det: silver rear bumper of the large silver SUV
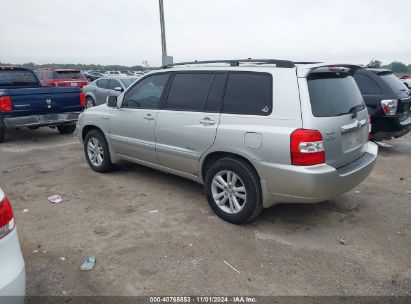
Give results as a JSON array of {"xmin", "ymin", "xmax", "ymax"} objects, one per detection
[{"xmin": 254, "ymin": 142, "xmax": 378, "ymax": 208}]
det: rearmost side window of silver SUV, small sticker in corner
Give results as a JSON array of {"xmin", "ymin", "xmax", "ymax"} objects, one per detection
[{"xmin": 223, "ymin": 73, "xmax": 272, "ymax": 115}]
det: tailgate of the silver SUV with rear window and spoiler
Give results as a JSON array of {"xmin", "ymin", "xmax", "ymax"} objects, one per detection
[{"xmin": 298, "ymin": 67, "xmax": 369, "ymax": 168}]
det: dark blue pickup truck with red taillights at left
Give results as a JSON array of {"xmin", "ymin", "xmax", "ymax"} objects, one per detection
[{"xmin": 0, "ymin": 67, "xmax": 86, "ymax": 142}]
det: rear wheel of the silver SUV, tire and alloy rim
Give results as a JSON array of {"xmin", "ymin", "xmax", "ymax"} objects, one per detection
[{"xmin": 205, "ymin": 158, "xmax": 262, "ymax": 224}]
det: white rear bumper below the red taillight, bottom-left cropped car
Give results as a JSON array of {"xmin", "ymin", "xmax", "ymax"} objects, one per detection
[{"xmin": 0, "ymin": 228, "xmax": 26, "ymax": 296}]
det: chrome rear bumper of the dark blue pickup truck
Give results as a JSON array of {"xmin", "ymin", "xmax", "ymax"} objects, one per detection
[{"xmin": 3, "ymin": 112, "xmax": 81, "ymax": 129}]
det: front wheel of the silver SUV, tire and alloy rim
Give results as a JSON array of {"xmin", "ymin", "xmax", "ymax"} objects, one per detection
[{"xmin": 84, "ymin": 130, "xmax": 113, "ymax": 173}]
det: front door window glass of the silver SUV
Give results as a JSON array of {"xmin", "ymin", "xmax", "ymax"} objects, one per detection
[{"xmin": 122, "ymin": 74, "xmax": 170, "ymax": 109}]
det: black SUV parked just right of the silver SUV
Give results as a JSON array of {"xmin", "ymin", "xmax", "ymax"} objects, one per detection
[{"xmin": 354, "ymin": 68, "xmax": 411, "ymax": 141}]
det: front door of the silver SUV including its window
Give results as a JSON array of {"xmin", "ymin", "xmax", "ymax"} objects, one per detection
[{"xmin": 109, "ymin": 74, "xmax": 170, "ymax": 164}]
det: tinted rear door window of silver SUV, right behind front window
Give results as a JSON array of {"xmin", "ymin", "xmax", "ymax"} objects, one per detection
[{"xmin": 166, "ymin": 73, "xmax": 214, "ymax": 111}]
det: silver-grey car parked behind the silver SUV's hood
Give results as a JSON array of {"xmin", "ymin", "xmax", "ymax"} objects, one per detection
[{"xmin": 83, "ymin": 76, "xmax": 137, "ymax": 108}]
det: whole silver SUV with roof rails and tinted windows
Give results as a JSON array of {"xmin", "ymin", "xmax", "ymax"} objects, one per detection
[{"xmin": 77, "ymin": 60, "xmax": 378, "ymax": 224}]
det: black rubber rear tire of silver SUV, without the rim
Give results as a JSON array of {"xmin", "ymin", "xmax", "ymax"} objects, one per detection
[{"xmin": 204, "ymin": 157, "xmax": 263, "ymax": 224}]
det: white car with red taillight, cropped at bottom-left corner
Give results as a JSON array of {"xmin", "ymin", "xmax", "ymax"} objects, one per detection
[{"xmin": 0, "ymin": 188, "xmax": 26, "ymax": 296}]
